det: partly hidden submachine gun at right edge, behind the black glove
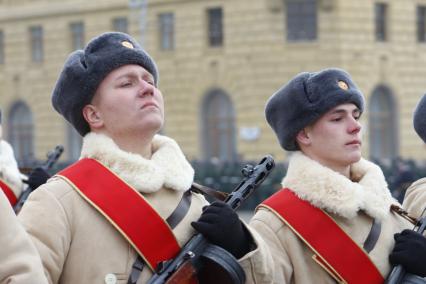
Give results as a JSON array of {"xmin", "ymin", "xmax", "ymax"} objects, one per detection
[{"xmin": 385, "ymin": 208, "xmax": 426, "ymax": 284}]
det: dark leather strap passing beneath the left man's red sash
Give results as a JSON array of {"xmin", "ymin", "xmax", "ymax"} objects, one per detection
[{"xmin": 127, "ymin": 190, "xmax": 192, "ymax": 284}]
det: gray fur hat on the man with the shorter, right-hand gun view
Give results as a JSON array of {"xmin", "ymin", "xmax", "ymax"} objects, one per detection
[{"xmin": 265, "ymin": 68, "xmax": 364, "ymax": 151}]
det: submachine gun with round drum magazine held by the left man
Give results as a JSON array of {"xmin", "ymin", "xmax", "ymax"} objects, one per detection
[{"xmin": 148, "ymin": 155, "xmax": 275, "ymax": 284}]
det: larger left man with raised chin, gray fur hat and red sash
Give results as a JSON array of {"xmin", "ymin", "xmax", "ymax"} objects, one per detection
[{"xmin": 19, "ymin": 32, "xmax": 266, "ymax": 283}]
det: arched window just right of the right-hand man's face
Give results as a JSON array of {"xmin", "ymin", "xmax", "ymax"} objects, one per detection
[{"xmin": 369, "ymin": 86, "xmax": 398, "ymax": 159}]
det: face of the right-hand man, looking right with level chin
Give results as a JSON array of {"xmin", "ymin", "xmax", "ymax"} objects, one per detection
[{"xmin": 299, "ymin": 103, "xmax": 362, "ymax": 169}]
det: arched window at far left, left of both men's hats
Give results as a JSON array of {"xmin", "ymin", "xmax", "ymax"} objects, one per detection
[{"xmin": 8, "ymin": 102, "xmax": 34, "ymax": 166}]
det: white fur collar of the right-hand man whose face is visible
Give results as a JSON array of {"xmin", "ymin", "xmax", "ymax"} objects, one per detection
[{"xmin": 282, "ymin": 152, "xmax": 397, "ymax": 220}]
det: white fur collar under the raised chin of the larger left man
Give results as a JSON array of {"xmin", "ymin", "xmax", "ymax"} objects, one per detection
[{"xmin": 81, "ymin": 133, "xmax": 194, "ymax": 193}]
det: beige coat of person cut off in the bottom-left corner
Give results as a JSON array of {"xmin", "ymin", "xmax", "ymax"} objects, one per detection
[{"xmin": 0, "ymin": 190, "xmax": 47, "ymax": 284}]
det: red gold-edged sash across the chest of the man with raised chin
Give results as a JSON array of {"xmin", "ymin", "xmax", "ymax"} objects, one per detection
[{"xmin": 57, "ymin": 158, "xmax": 180, "ymax": 270}]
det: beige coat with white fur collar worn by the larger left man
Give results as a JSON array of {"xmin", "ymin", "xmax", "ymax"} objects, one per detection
[{"xmin": 19, "ymin": 133, "xmax": 262, "ymax": 284}]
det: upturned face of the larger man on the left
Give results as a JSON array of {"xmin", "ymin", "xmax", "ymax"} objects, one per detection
[{"xmin": 88, "ymin": 65, "xmax": 164, "ymax": 140}]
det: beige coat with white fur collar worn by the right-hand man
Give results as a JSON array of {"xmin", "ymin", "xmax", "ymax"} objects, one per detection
[{"xmin": 250, "ymin": 152, "xmax": 412, "ymax": 284}]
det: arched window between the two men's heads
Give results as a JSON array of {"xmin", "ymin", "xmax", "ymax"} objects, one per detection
[{"xmin": 201, "ymin": 89, "xmax": 237, "ymax": 161}]
